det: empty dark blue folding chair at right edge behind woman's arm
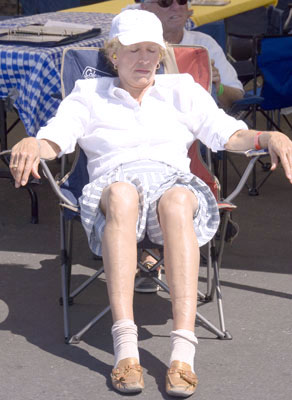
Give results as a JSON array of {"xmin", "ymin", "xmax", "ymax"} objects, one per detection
[{"xmin": 229, "ymin": 35, "xmax": 292, "ymax": 195}]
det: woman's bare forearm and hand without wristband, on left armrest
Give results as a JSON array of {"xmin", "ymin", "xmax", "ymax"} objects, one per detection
[{"xmin": 9, "ymin": 138, "xmax": 60, "ymax": 188}]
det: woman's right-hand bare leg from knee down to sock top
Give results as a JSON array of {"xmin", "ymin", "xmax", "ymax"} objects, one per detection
[{"xmin": 158, "ymin": 187, "xmax": 200, "ymax": 332}]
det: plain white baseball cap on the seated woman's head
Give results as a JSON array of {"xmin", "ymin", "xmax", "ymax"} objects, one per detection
[{"xmin": 109, "ymin": 10, "xmax": 166, "ymax": 49}]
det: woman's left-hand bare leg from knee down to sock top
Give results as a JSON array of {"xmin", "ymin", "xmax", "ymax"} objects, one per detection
[{"xmin": 101, "ymin": 182, "xmax": 139, "ymax": 322}]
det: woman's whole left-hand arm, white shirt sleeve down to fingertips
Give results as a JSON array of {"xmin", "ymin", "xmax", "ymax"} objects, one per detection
[{"xmin": 10, "ymin": 79, "xmax": 96, "ymax": 188}]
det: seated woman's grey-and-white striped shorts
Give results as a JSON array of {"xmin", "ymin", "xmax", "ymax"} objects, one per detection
[{"xmin": 79, "ymin": 160, "xmax": 219, "ymax": 256}]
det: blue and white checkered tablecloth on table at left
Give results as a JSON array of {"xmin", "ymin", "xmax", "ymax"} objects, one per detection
[{"xmin": 0, "ymin": 12, "xmax": 113, "ymax": 136}]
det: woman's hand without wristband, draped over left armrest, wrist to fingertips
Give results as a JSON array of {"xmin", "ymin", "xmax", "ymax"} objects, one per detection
[{"xmin": 9, "ymin": 138, "xmax": 40, "ymax": 188}]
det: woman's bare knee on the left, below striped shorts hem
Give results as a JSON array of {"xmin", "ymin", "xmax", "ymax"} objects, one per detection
[{"xmin": 101, "ymin": 182, "xmax": 139, "ymax": 218}]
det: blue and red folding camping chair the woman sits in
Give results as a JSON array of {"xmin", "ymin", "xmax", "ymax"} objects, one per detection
[{"xmin": 32, "ymin": 46, "xmax": 266, "ymax": 343}]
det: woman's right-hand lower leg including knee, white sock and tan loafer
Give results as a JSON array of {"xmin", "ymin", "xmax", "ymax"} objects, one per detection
[{"xmin": 158, "ymin": 187, "xmax": 199, "ymax": 378}]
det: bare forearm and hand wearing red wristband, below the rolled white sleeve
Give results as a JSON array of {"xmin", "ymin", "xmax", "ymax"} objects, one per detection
[{"xmin": 225, "ymin": 130, "xmax": 292, "ymax": 183}]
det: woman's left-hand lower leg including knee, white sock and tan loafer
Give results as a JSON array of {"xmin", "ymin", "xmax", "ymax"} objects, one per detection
[{"xmin": 101, "ymin": 182, "xmax": 144, "ymax": 393}]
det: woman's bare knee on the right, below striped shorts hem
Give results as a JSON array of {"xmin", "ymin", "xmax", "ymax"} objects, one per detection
[{"xmin": 158, "ymin": 187, "xmax": 198, "ymax": 220}]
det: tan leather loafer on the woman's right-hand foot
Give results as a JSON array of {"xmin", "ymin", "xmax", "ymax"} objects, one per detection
[{"xmin": 166, "ymin": 361, "xmax": 198, "ymax": 397}]
